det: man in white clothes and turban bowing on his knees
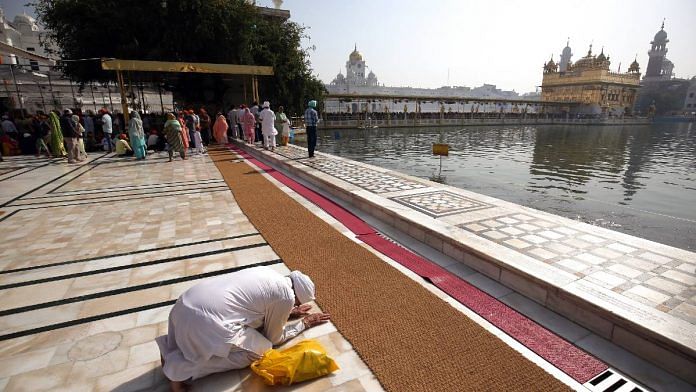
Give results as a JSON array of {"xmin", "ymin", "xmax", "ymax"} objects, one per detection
[{"xmin": 156, "ymin": 267, "xmax": 329, "ymax": 392}]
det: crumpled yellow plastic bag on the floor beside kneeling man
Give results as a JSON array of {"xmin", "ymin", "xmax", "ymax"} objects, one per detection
[{"xmin": 251, "ymin": 340, "xmax": 338, "ymax": 385}]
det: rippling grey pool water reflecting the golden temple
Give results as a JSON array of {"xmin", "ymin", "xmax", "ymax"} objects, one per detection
[{"xmin": 304, "ymin": 124, "xmax": 696, "ymax": 249}]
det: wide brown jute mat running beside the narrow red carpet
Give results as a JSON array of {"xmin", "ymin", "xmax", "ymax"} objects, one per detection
[{"xmin": 209, "ymin": 148, "xmax": 570, "ymax": 391}]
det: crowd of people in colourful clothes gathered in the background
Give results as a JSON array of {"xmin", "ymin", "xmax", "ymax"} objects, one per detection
[{"xmin": 0, "ymin": 101, "xmax": 318, "ymax": 164}]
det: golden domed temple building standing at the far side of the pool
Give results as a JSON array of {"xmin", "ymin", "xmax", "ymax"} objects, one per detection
[{"xmin": 541, "ymin": 45, "xmax": 640, "ymax": 116}]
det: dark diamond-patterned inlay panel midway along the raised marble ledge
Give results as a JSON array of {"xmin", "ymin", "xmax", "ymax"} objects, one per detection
[{"xmin": 390, "ymin": 191, "xmax": 493, "ymax": 218}]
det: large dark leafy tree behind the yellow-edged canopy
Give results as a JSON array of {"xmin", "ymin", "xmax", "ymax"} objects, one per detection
[{"xmin": 32, "ymin": 0, "xmax": 324, "ymax": 112}]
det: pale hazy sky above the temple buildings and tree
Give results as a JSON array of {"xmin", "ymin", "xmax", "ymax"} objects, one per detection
[{"xmin": 0, "ymin": 0, "xmax": 696, "ymax": 93}]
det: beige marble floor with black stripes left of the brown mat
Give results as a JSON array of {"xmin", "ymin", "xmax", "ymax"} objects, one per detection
[{"xmin": 0, "ymin": 154, "xmax": 381, "ymax": 391}]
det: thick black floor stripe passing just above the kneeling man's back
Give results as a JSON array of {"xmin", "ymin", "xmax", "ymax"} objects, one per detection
[{"xmin": 0, "ymin": 259, "xmax": 277, "ymax": 317}]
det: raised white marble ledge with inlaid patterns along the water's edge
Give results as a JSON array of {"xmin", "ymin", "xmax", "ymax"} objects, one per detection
[{"xmin": 245, "ymin": 145, "xmax": 696, "ymax": 383}]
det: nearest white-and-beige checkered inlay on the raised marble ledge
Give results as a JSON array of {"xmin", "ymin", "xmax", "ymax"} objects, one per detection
[{"xmin": 458, "ymin": 213, "xmax": 696, "ymax": 323}]
